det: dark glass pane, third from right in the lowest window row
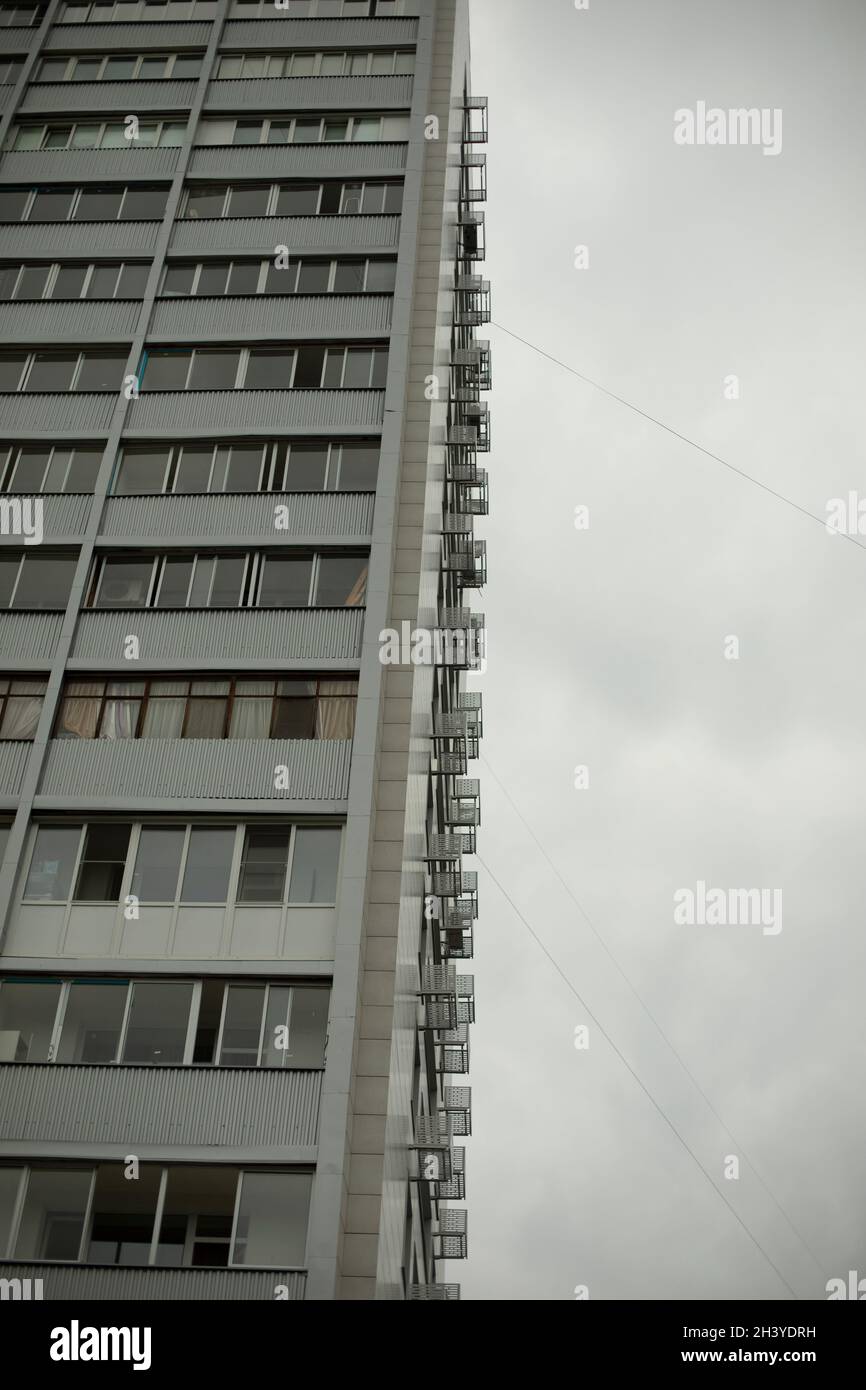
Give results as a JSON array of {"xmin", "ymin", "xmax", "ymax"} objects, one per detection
[{"xmin": 86, "ymin": 1162, "xmax": 163, "ymax": 1266}]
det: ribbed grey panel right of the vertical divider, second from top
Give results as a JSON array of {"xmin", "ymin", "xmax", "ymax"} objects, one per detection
[{"xmin": 204, "ymin": 73, "xmax": 413, "ymax": 111}]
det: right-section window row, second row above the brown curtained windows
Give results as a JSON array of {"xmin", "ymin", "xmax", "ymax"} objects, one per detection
[{"xmin": 111, "ymin": 439, "xmax": 379, "ymax": 496}]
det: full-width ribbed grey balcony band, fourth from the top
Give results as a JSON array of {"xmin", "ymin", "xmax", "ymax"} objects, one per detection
[{"xmin": 0, "ymin": 215, "xmax": 400, "ymax": 260}]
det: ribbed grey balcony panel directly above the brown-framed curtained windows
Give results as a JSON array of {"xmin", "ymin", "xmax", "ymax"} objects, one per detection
[{"xmin": 69, "ymin": 609, "xmax": 364, "ymax": 670}]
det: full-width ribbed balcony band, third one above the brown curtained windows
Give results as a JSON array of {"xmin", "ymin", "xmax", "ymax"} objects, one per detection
[{"xmin": 0, "ymin": 391, "xmax": 385, "ymax": 442}]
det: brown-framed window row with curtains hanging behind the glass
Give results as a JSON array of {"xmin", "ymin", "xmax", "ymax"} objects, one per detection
[{"xmin": 54, "ymin": 677, "xmax": 357, "ymax": 745}]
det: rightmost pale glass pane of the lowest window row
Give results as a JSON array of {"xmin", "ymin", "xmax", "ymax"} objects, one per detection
[{"xmin": 232, "ymin": 1173, "xmax": 313, "ymax": 1268}]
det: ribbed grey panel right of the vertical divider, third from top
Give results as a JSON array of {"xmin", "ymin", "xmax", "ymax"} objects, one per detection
[{"xmin": 187, "ymin": 140, "xmax": 409, "ymax": 179}]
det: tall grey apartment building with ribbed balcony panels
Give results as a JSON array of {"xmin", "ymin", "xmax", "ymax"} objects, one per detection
[{"xmin": 0, "ymin": 0, "xmax": 491, "ymax": 1300}]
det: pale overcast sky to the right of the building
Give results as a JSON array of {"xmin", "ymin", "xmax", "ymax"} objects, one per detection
[{"xmin": 461, "ymin": 0, "xmax": 866, "ymax": 1300}]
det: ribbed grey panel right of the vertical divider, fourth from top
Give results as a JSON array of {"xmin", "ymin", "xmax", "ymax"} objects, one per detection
[{"xmin": 169, "ymin": 215, "xmax": 400, "ymax": 256}]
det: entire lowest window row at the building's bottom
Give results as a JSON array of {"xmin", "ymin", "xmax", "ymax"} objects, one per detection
[{"xmin": 0, "ymin": 1161, "xmax": 313, "ymax": 1269}]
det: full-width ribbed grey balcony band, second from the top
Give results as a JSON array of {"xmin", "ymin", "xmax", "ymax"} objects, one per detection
[{"xmin": 18, "ymin": 72, "xmax": 413, "ymax": 115}]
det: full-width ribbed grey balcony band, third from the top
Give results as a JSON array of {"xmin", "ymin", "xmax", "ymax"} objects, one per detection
[{"xmin": 0, "ymin": 140, "xmax": 409, "ymax": 183}]
